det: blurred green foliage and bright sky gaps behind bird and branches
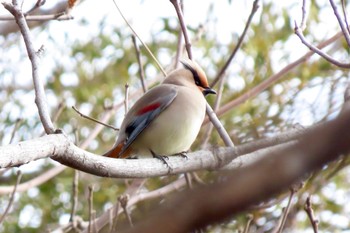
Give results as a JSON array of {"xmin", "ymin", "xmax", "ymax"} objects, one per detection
[{"xmin": 0, "ymin": 0, "xmax": 350, "ymax": 232}]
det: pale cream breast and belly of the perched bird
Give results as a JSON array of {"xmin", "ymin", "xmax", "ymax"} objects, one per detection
[{"xmin": 133, "ymin": 87, "xmax": 206, "ymax": 155}]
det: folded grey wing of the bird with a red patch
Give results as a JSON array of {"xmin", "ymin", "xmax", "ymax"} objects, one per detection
[{"xmin": 119, "ymin": 85, "xmax": 178, "ymax": 155}]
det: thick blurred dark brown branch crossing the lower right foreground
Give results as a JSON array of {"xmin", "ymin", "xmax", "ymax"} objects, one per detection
[{"xmin": 122, "ymin": 107, "xmax": 350, "ymax": 233}]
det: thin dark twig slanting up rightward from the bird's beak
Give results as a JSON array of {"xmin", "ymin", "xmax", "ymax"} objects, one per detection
[{"xmin": 210, "ymin": 0, "xmax": 259, "ymax": 87}]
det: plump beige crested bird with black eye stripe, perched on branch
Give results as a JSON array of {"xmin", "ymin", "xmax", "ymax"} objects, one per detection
[{"xmin": 104, "ymin": 60, "xmax": 216, "ymax": 163}]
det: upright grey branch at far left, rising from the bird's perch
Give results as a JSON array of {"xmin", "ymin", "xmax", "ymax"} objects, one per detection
[{"xmin": 2, "ymin": 0, "xmax": 55, "ymax": 134}]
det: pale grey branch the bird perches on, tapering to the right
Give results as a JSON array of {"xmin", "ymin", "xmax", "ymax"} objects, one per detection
[{"xmin": 0, "ymin": 118, "xmax": 321, "ymax": 178}]
